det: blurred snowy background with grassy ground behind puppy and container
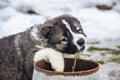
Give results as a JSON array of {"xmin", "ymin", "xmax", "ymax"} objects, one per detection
[{"xmin": 0, "ymin": 0, "xmax": 120, "ymax": 80}]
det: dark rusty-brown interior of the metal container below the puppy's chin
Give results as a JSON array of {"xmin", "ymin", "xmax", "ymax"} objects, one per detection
[{"xmin": 35, "ymin": 58, "xmax": 99, "ymax": 72}]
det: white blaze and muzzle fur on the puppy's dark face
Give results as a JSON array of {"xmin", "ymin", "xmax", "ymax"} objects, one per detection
[{"xmin": 62, "ymin": 20, "xmax": 86, "ymax": 50}]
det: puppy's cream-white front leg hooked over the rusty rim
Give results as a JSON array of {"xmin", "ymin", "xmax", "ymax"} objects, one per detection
[{"xmin": 33, "ymin": 48, "xmax": 64, "ymax": 72}]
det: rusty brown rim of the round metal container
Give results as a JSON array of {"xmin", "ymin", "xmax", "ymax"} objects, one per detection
[{"xmin": 34, "ymin": 59, "xmax": 99, "ymax": 76}]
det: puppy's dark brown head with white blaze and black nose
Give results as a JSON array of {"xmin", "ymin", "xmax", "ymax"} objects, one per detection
[{"xmin": 41, "ymin": 15, "xmax": 86, "ymax": 54}]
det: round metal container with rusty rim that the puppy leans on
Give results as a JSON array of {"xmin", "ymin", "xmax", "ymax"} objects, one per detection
[{"xmin": 32, "ymin": 58, "xmax": 100, "ymax": 80}]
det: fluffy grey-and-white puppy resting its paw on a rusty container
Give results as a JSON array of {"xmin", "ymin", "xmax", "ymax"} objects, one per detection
[{"xmin": 0, "ymin": 14, "xmax": 86, "ymax": 80}]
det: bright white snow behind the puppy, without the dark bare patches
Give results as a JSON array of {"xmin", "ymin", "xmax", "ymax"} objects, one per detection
[{"xmin": 0, "ymin": 0, "xmax": 120, "ymax": 40}]
